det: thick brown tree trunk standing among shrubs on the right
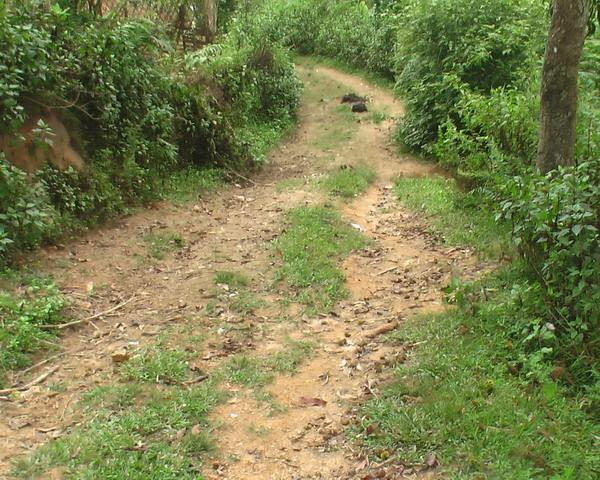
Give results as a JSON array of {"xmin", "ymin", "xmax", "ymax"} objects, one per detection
[{"xmin": 537, "ymin": 0, "xmax": 589, "ymax": 174}]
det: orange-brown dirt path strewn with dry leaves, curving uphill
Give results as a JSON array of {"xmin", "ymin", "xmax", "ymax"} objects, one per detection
[{"xmin": 0, "ymin": 61, "xmax": 478, "ymax": 480}]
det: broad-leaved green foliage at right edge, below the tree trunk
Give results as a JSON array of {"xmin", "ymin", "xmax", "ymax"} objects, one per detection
[{"xmin": 502, "ymin": 161, "xmax": 600, "ymax": 381}]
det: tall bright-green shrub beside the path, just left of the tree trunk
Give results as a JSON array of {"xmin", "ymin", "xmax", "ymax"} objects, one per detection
[{"xmin": 396, "ymin": 0, "xmax": 545, "ymax": 149}]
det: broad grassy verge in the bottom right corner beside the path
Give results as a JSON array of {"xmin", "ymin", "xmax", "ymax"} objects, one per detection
[{"xmin": 358, "ymin": 270, "xmax": 600, "ymax": 480}]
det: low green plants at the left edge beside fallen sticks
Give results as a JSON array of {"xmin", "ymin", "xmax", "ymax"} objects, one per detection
[{"xmin": 0, "ymin": 270, "xmax": 66, "ymax": 385}]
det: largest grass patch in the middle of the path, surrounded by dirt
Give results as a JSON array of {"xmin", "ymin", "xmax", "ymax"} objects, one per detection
[{"xmin": 274, "ymin": 207, "xmax": 367, "ymax": 313}]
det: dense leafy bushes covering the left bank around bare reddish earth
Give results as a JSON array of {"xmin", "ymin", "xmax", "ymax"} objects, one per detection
[{"xmin": 0, "ymin": 0, "xmax": 300, "ymax": 259}]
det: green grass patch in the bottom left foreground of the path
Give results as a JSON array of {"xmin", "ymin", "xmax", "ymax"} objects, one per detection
[{"xmin": 14, "ymin": 380, "xmax": 224, "ymax": 480}]
